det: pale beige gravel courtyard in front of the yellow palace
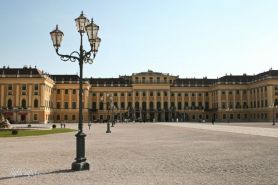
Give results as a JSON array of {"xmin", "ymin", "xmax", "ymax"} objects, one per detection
[{"xmin": 0, "ymin": 123, "xmax": 278, "ymax": 185}]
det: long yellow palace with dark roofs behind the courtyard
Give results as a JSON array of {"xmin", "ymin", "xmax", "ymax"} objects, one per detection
[{"xmin": 0, "ymin": 67, "xmax": 278, "ymax": 123}]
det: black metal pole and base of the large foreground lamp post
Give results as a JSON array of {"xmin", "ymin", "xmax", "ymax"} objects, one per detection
[{"xmin": 71, "ymin": 33, "xmax": 90, "ymax": 171}]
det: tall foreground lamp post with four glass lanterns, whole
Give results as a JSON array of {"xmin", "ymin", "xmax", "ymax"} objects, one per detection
[{"xmin": 50, "ymin": 12, "xmax": 101, "ymax": 171}]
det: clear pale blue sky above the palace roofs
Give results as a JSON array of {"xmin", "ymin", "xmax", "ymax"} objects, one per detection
[{"xmin": 0, "ymin": 0, "xmax": 278, "ymax": 78}]
